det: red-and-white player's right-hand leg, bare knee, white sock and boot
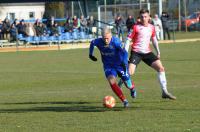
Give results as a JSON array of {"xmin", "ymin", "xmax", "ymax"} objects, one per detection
[{"xmin": 151, "ymin": 60, "xmax": 176, "ymax": 99}]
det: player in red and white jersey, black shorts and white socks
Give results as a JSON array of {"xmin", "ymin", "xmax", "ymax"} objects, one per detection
[{"xmin": 125, "ymin": 9, "xmax": 176, "ymax": 100}]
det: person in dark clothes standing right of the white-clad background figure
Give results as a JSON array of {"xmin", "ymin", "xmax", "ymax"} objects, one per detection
[{"xmin": 161, "ymin": 12, "xmax": 170, "ymax": 40}]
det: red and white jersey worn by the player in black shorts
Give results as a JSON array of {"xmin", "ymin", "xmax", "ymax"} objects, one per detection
[{"xmin": 128, "ymin": 24, "xmax": 155, "ymax": 54}]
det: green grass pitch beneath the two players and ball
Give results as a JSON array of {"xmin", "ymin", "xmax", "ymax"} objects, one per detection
[{"xmin": 0, "ymin": 42, "xmax": 200, "ymax": 132}]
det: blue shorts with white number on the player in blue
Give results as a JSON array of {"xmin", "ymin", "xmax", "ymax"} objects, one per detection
[{"xmin": 104, "ymin": 66, "xmax": 130, "ymax": 81}]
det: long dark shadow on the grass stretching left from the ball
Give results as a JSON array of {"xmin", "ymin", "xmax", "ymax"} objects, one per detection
[{"xmin": 0, "ymin": 102, "xmax": 124, "ymax": 113}]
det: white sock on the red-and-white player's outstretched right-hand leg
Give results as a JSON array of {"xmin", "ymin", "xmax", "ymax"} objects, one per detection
[{"xmin": 158, "ymin": 72, "xmax": 168, "ymax": 93}]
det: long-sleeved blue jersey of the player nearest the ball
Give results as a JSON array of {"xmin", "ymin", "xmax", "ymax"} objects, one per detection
[{"xmin": 89, "ymin": 37, "xmax": 128, "ymax": 68}]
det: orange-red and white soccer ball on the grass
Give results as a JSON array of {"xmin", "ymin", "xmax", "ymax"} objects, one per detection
[{"xmin": 103, "ymin": 95, "xmax": 116, "ymax": 108}]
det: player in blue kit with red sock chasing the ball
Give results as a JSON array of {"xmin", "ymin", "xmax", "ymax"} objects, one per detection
[{"xmin": 89, "ymin": 28, "xmax": 136, "ymax": 107}]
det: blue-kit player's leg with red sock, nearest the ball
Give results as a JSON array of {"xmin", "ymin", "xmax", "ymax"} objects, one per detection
[{"xmin": 105, "ymin": 69, "xmax": 128, "ymax": 107}]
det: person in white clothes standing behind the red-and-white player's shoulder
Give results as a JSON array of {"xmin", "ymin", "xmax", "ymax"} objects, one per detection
[{"xmin": 153, "ymin": 14, "xmax": 162, "ymax": 40}]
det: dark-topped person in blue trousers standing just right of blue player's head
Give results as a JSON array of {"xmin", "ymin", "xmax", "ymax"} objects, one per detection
[{"xmin": 115, "ymin": 15, "xmax": 125, "ymax": 41}]
